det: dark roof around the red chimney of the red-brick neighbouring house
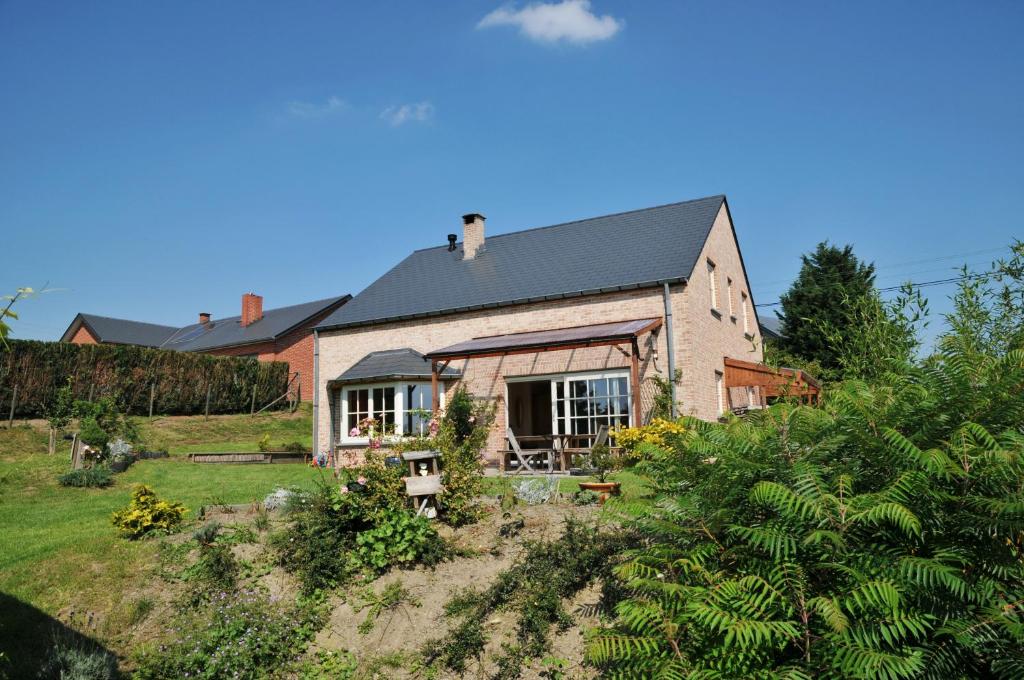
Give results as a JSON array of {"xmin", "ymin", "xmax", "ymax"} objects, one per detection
[{"xmin": 161, "ymin": 295, "xmax": 351, "ymax": 351}]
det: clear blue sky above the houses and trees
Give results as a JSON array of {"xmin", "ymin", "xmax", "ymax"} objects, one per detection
[{"xmin": 0, "ymin": 0, "xmax": 1024, "ymax": 346}]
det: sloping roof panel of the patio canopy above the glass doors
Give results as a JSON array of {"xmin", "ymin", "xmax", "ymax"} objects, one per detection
[{"xmin": 427, "ymin": 318, "xmax": 662, "ymax": 359}]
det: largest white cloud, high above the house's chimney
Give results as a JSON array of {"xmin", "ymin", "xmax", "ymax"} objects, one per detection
[{"xmin": 476, "ymin": 0, "xmax": 626, "ymax": 45}]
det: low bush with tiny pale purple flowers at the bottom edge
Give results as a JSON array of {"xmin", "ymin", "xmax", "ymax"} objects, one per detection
[{"xmin": 134, "ymin": 591, "xmax": 324, "ymax": 680}]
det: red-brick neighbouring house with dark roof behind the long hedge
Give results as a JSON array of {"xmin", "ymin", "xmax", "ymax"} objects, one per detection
[{"xmin": 60, "ymin": 293, "xmax": 352, "ymax": 400}]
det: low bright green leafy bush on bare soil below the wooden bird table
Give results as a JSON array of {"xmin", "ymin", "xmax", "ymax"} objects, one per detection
[{"xmin": 350, "ymin": 510, "xmax": 443, "ymax": 571}]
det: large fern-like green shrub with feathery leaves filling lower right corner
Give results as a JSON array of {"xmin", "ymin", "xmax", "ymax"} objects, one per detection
[{"xmin": 588, "ymin": 345, "xmax": 1024, "ymax": 680}]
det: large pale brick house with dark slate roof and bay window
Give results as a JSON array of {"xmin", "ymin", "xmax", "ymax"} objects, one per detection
[{"xmin": 313, "ymin": 196, "xmax": 762, "ymax": 462}]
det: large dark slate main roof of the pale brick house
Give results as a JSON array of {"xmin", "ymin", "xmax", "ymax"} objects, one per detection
[{"xmin": 319, "ymin": 196, "xmax": 725, "ymax": 330}]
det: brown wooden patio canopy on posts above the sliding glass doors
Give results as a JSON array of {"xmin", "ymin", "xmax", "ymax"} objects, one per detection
[{"xmin": 424, "ymin": 318, "xmax": 662, "ymax": 423}]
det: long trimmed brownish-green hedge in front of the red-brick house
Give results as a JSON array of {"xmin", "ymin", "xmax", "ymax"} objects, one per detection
[{"xmin": 0, "ymin": 340, "xmax": 289, "ymax": 418}]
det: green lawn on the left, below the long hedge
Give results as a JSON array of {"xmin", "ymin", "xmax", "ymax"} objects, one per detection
[{"xmin": 0, "ymin": 411, "xmax": 319, "ymax": 673}]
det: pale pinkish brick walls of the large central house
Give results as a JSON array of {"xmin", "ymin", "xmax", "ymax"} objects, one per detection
[{"xmin": 315, "ymin": 200, "xmax": 761, "ymax": 460}]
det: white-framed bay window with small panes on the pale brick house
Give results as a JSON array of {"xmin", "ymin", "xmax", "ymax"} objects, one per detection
[{"xmin": 332, "ymin": 383, "xmax": 443, "ymax": 443}]
